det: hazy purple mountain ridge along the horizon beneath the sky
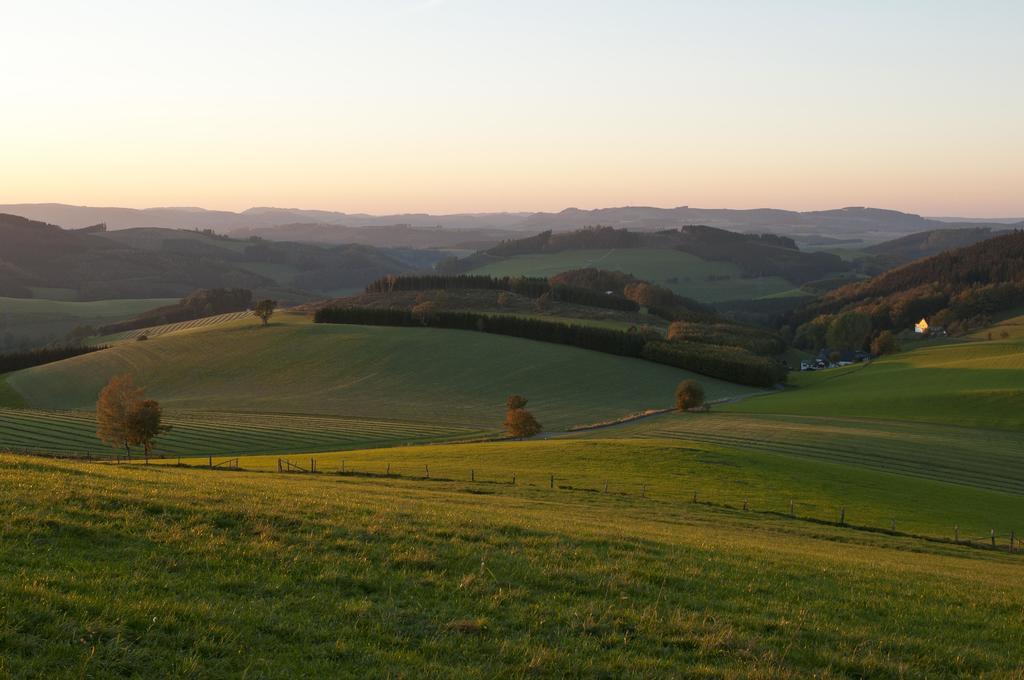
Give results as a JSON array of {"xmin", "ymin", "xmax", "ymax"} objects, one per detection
[{"xmin": 0, "ymin": 203, "xmax": 1024, "ymax": 246}]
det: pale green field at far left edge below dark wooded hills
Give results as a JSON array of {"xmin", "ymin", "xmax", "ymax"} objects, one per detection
[{"xmin": 0, "ymin": 298, "xmax": 177, "ymax": 347}]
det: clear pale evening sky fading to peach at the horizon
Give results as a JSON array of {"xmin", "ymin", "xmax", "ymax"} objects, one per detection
[{"xmin": 0, "ymin": 0, "xmax": 1024, "ymax": 217}]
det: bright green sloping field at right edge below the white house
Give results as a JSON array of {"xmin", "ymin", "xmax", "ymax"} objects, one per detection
[{"xmin": 729, "ymin": 333, "xmax": 1024, "ymax": 430}]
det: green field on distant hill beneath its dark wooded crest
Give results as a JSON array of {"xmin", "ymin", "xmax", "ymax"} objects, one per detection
[{"xmin": 472, "ymin": 248, "xmax": 794, "ymax": 302}]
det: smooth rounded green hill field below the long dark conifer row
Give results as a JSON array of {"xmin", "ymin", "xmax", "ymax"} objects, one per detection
[{"xmin": 6, "ymin": 314, "xmax": 752, "ymax": 431}]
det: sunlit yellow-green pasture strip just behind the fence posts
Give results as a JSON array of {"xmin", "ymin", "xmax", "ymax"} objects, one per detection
[{"xmin": 144, "ymin": 433, "xmax": 1024, "ymax": 546}]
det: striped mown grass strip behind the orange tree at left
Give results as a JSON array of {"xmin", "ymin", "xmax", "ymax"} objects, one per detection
[{"xmin": 0, "ymin": 409, "xmax": 479, "ymax": 457}]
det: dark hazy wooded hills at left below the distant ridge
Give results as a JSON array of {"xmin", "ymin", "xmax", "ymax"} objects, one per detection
[{"xmin": 0, "ymin": 215, "xmax": 440, "ymax": 302}]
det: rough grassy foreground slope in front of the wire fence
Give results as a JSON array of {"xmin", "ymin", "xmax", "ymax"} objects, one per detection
[{"xmin": 0, "ymin": 454, "xmax": 1024, "ymax": 678}]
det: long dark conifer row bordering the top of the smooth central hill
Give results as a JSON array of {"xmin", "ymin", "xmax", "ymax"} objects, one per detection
[{"xmin": 314, "ymin": 307, "xmax": 785, "ymax": 387}]
